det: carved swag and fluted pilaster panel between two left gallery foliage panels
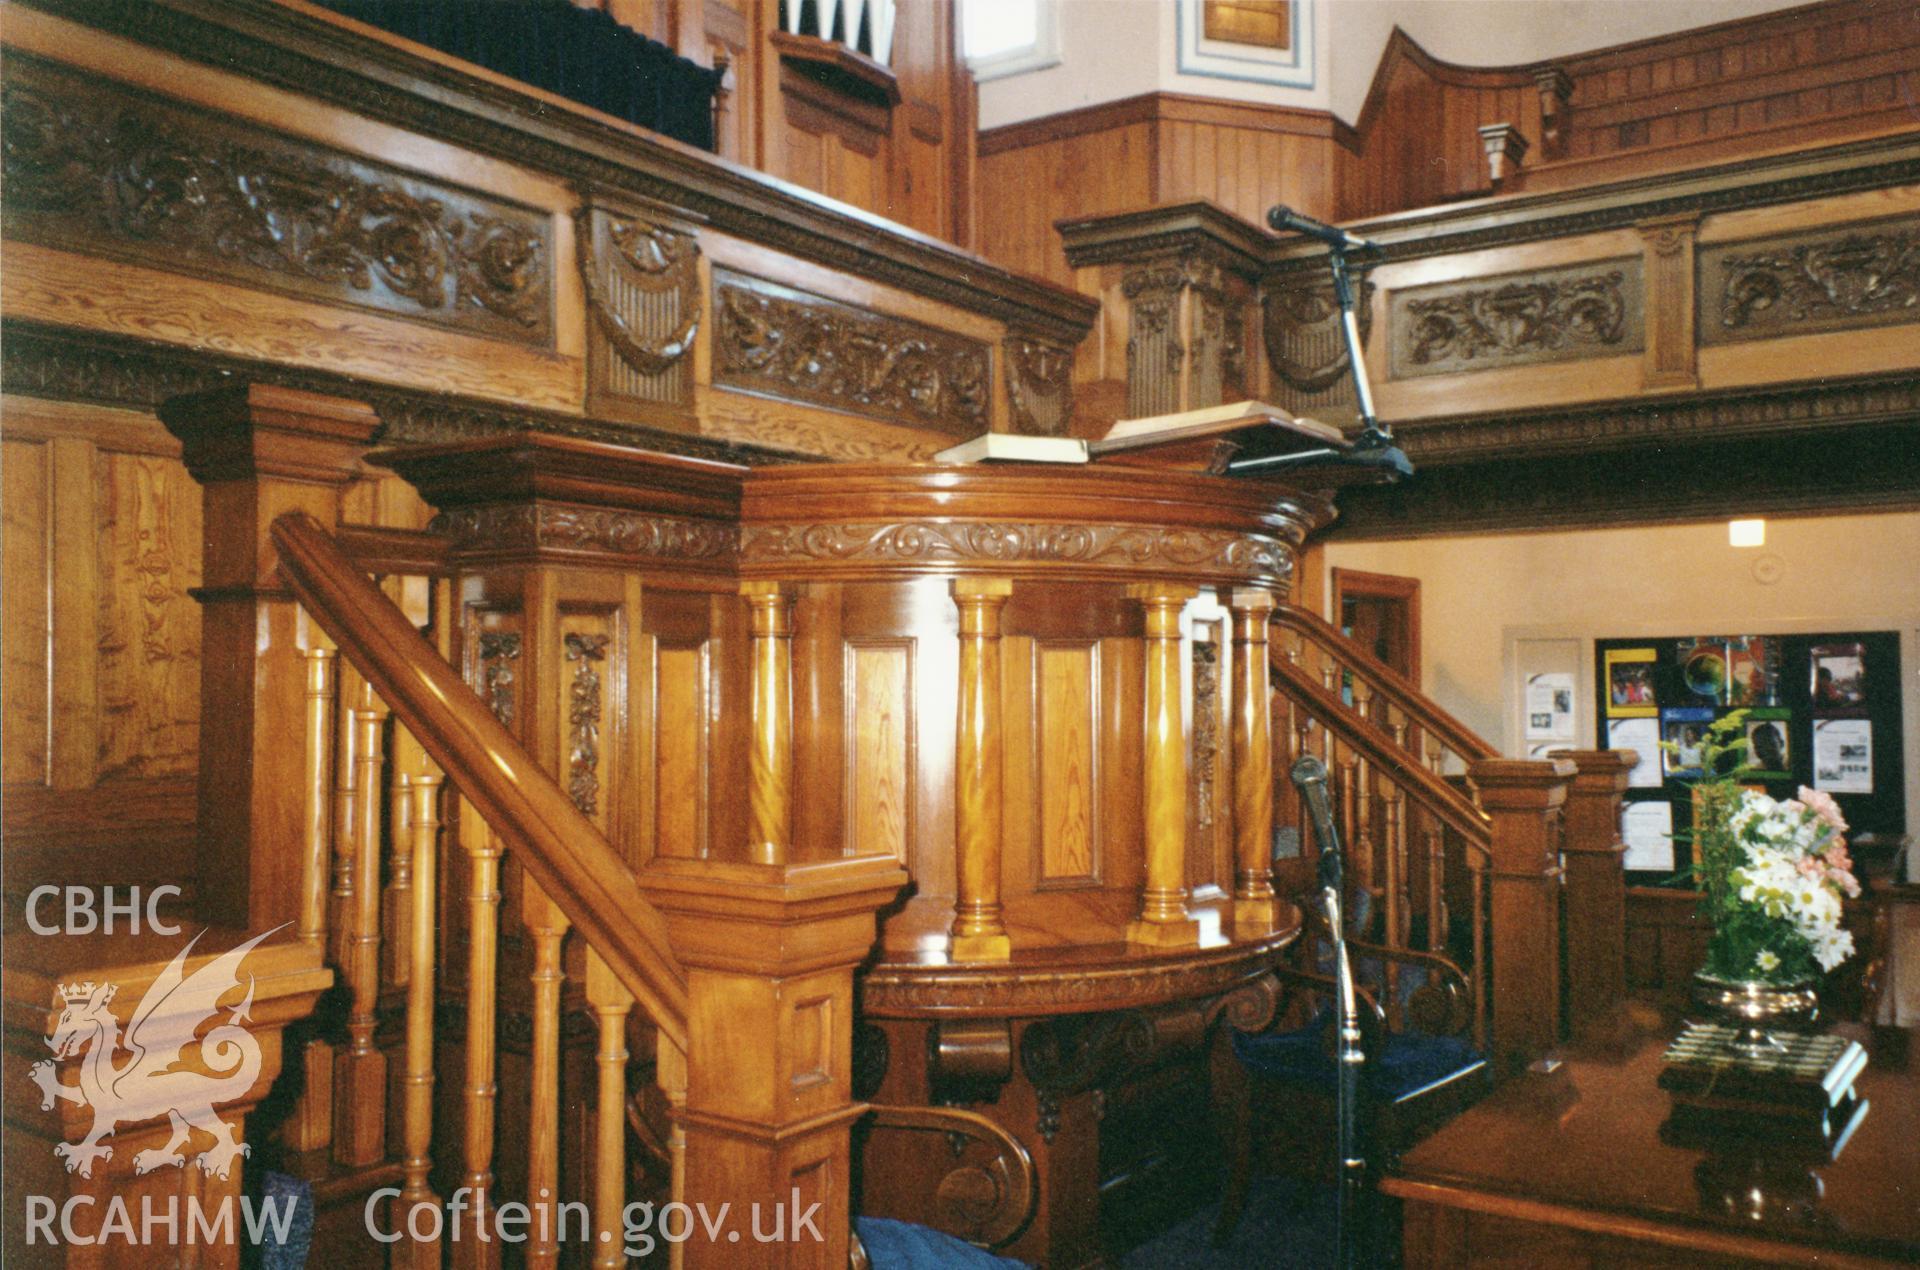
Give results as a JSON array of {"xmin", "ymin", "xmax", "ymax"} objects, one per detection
[{"xmin": 580, "ymin": 204, "xmax": 703, "ymax": 409}]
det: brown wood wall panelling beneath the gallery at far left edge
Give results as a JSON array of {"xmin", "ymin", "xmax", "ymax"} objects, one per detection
[{"xmin": 0, "ymin": 396, "xmax": 200, "ymax": 890}]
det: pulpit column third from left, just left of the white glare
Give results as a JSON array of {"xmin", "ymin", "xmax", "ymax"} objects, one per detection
[{"xmin": 1127, "ymin": 582, "xmax": 1200, "ymax": 947}]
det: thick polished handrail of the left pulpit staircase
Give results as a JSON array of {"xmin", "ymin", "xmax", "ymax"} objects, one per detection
[{"xmin": 273, "ymin": 511, "xmax": 687, "ymax": 1051}]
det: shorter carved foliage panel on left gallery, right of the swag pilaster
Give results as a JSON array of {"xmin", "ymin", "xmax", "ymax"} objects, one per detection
[{"xmin": 712, "ymin": 267, "xmax": 993, "ymax": 436}]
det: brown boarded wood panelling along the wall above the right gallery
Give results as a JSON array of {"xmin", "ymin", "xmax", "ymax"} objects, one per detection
[{"xmin": 979, "ymin": 0, "xmax": 1920, "ymax": 282}]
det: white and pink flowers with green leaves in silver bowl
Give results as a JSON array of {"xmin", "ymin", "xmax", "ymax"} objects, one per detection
[{"xmin": 1666, "ymin": 711, "xmax": 1860, "ymax": 984}]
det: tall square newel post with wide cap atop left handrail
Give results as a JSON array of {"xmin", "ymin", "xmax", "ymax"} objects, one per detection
[{"xmin": 159, "ymin": 382, "xmax": 380, "ymax": 930}]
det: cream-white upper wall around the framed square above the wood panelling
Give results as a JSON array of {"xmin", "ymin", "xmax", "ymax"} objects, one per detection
[{"xmin": 979, "ymin": 0, "xmax": 1803, "ymax": 129}]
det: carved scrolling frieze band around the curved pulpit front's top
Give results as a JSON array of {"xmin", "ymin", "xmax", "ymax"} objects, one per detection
[{"xmin": 741, "ymin": 521, "xmax": 1292, "ymax": 578}]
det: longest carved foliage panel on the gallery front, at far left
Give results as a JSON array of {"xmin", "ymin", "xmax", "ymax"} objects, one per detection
[{"xmin": 0, "ymin": 54, "xmax": 553, "ymax": 348}]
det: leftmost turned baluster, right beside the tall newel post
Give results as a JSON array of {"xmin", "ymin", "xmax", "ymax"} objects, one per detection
[{"xmin": 284, "ymin": 609, "xmax": 338, "ymax": 1151}]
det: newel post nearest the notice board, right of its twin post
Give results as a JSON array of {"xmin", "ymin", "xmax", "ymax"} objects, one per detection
[{"xmin": 1553, "ymin": 749, "xmax": 1638, "ymax": 1032}]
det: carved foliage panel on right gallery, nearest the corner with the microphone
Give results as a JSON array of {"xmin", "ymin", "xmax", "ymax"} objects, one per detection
[{"xmin": 1388, "ymin": 257, "xmax": 1645, "ymax": 379}]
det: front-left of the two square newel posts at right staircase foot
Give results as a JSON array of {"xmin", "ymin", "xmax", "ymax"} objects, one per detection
[{"xmin": 1467, "ymin": 759, "xmax": 1574, "ymax": 1072}]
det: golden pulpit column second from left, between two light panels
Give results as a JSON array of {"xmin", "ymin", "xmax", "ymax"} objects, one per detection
[{"xmin": 948, "ymin": 578, "xmax": 1014, "ymax": 961}]
